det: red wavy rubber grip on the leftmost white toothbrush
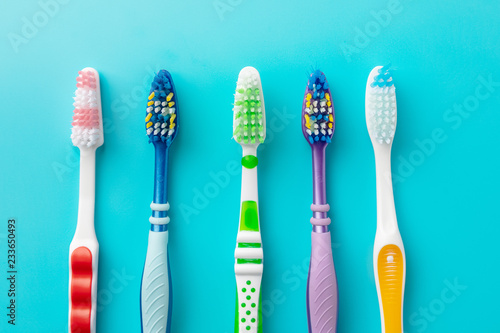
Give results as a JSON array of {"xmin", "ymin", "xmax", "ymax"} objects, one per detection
[{"xmin": 70, "ymin": 246, "xmax": 92, "ymax": 333}]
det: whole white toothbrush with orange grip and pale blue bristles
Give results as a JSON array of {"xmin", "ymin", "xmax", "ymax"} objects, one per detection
[{"xmin": 365, "ymin": 66, "xmax": 406, "ymax": 333}]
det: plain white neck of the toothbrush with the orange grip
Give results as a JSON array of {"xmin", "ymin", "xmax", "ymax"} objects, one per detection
[{"xmin": 375, "ymin": 147, "xmax": 398, "ymax": 233}]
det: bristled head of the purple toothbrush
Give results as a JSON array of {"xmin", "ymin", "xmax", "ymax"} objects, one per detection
[{"xmin": 302, "ymin": 70, "xmax": 335, "ymax": 146}]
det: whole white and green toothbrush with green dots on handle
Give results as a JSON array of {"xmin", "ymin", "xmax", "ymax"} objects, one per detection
[{"xmin": 233, "ymin": 67, "xmax": 266, "ymax": 333}]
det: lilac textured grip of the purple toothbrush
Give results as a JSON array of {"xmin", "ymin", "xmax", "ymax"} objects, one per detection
[{"xmin": 307, "ymin": 232, "xmax": 338, "ymax": 333}]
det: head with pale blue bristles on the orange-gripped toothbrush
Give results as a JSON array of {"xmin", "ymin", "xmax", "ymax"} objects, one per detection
[{"xmin": 365, "ymin": 65, "xmax": 397, "ymax": 145}]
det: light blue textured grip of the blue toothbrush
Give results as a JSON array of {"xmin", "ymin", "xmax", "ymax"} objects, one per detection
[{"xmin": 141, "ymin": 231, "xmax": 171, "ymax": 333}]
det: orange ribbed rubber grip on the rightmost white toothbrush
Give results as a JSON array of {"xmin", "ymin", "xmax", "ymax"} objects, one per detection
[{"xmin": 377, "ymin": 244, "xmax": 404, "ymax": 333}]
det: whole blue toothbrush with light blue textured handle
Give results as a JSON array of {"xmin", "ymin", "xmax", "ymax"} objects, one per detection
[{"xmin": 140, "ymin": 70, "xmax": 178, "ymax": 333}]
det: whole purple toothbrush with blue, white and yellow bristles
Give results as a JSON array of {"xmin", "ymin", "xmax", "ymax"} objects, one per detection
[{"xmin": 302, "ymin": 70, "xmax": 338, "ymax": 333}]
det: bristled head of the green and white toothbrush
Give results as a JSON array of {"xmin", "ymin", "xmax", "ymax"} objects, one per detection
[{"xmin": 233, "ymin": 67, "xmax": 266, "ymax": 145}]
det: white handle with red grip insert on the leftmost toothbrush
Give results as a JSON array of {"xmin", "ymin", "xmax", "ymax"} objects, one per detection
[{"xmin": 68, "ymin": 239, "xmax": 99, "ymax": 333}]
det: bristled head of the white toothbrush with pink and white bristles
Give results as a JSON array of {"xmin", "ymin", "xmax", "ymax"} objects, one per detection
[{"xmin": 71, "ymin": 67, "xmax": 104, "ymax": 149}]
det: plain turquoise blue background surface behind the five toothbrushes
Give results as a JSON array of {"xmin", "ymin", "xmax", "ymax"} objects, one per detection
[{"xmin": 0, "ymin": 0, "xmax": 500, "ymax": 333}]
